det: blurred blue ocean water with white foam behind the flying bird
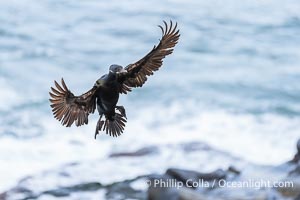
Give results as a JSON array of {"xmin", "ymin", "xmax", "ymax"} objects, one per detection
[{"xmin": 0, "ymin": 0, "xmax": 300, "ymax": 194}]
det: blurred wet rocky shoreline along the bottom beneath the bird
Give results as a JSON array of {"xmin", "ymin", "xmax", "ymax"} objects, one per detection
[{"xmin": 0, "ymin": 140, "xmax": 300, "ymax": 200}]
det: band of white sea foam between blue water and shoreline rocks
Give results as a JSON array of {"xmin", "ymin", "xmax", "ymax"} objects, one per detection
[{"xmin": 0, "ymin": 103, "xmax": 299, "ymax": 191}]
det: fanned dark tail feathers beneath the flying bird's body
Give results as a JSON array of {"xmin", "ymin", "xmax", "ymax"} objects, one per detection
[{"xmin": 95, "ymin": 112, "xmax": 127, "ymax": 139}]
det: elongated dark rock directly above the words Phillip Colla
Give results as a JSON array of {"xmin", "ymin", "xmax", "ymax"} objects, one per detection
[{"xmin": 166, "ymin": 168, "xmax": 226, "ymax": 188}]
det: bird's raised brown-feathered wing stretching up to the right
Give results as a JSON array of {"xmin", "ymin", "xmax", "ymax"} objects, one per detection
[{"xmin": 120, "ymin": 21, "xmax": 180, "ymax": 94}]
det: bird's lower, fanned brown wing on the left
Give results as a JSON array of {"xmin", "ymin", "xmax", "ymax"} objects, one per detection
[{"xmin": 49, "ymin": 79, "xmax": 97, "ymax": 127}]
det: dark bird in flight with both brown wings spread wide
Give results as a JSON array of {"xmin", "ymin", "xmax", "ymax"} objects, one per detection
[{"xmin": 49, "ymin": 21, "xmax": 180, "ymax": 138}]
